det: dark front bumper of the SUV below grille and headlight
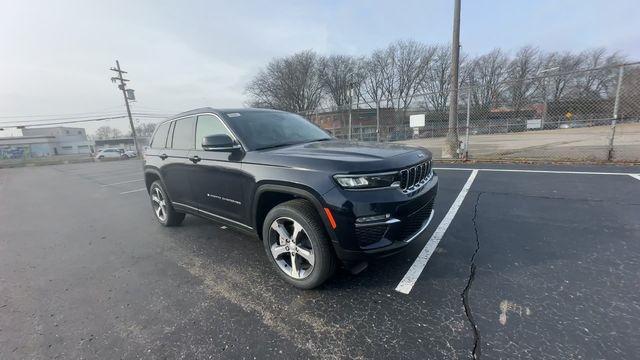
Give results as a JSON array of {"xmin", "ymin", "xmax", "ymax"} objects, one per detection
[{"xmin": 323, "ymin": 173, "xmax": 438, "ymax": 262}]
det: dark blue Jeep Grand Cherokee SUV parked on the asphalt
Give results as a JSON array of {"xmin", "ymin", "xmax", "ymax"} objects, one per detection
[{"xmin": 144, "ymin": 108, "xmax": 438, "ymax": 289}]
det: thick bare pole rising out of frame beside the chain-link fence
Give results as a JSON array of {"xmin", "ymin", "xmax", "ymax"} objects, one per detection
[{"xmin": 442, "ymin": 0, "xmax": 460, "ymax": 159}]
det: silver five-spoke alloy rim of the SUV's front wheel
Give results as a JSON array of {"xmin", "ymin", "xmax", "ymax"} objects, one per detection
[{"xmin": 269, "ymin": 217, "xmax": 315, "ymax": 280}]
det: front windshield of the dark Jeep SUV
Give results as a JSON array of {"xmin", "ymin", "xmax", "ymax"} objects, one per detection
[{"xmin": 226, "ymin": 111, "xmax": 331, "ymax": 150}]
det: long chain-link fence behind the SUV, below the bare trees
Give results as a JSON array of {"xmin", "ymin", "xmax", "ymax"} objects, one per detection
[{"xmin": 302, "ymin": 63, "xmax": 640, "ymax": 162}]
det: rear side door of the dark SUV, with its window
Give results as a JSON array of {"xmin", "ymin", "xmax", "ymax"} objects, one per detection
[{"xmin": 160, "ymin": 116, "xmax": 196, "ymax": 207}]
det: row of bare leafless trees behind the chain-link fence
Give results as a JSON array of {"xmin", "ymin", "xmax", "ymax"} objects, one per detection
[{"xmin": 245, "ymin": 40, "xmax": 627, "ymax": 112}]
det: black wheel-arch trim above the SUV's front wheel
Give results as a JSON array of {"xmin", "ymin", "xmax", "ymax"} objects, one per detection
[{"xmin": 251, "ymin": 182, "xmax": 338, "ymax": 243}]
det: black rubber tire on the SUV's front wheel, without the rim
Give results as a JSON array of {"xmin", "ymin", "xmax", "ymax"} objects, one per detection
[{"xmin": 262, "ymin": 199, "xmax": 337, "ymax": 289}]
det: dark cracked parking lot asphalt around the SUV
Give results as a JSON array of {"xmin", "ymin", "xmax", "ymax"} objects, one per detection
[{"xmin": 0, "ymin": 160, "xmax": 640, "ymax": 359}]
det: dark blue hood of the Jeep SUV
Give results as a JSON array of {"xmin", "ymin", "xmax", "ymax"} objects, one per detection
[{"xmin": 245, "ymin": 140, "xmax": 431, "ymax": 172}]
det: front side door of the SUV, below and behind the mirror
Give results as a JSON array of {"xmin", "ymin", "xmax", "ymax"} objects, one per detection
[{"xmin": 189, "ymin": 114, "xmax": 249, "ymax": 225}]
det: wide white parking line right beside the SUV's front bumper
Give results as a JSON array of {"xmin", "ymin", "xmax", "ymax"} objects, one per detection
[{"xmin": 396, "ymin": 169, "xmax": 478, "ymax": 294}]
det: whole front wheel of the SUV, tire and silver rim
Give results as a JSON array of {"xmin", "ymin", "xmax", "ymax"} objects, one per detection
[{"xmin": 262, "ymin": 199, "xmax": 336, "ymax": 289}]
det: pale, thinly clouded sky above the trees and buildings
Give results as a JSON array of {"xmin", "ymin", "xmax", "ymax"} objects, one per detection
[{"xmin": 0, "ymin": 0, "xmax": 640, "ymax": 135}]
